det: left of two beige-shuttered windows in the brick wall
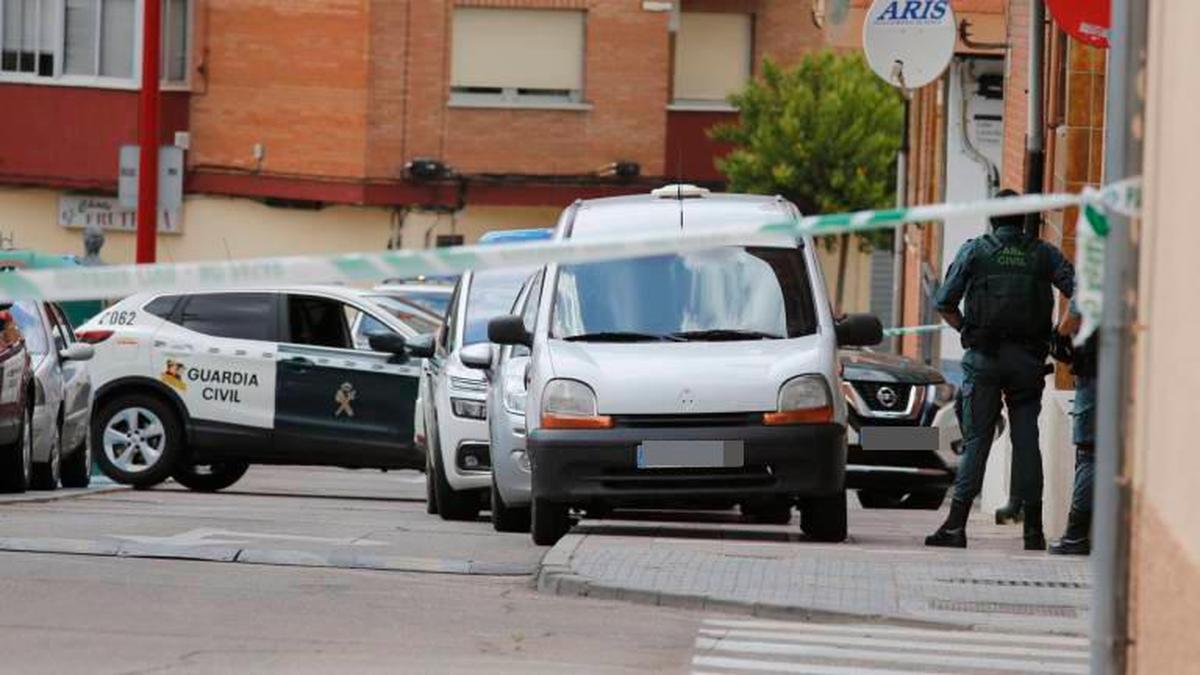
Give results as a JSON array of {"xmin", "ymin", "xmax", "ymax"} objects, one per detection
[{"xmin": 450, "ymin": 7, "xmax": 586, "ymax": 107}]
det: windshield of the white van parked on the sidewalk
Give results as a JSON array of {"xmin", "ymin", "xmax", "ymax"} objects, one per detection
[{"xmin": 551, "ymin": 246, "xmax": 817, "ymax": 341}]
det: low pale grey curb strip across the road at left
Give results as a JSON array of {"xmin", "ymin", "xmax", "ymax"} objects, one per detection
[{"xmin": 0, "ymin": 537, "xmax": 535, "ymax": 577}]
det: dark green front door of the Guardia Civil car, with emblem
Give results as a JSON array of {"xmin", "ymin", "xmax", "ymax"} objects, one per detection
[{"xmin": 275, "ymin": 293, "xmax": 418, "ymax": 467}]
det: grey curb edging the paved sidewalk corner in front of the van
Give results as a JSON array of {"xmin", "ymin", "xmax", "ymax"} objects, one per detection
[{"xmin": 534, "ymin": 534, "xmax": 1032, "ymax": 631}]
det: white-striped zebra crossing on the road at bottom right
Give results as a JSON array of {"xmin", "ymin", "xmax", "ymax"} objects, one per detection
[{"xmin": 691, "ymin": 619, "xmax": 1088, "ymax": 675}]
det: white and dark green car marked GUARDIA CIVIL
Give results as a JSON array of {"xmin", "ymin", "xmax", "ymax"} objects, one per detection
[{"xmin": 78, "ymin": 287, "xmax": 430, "ymax": 491}]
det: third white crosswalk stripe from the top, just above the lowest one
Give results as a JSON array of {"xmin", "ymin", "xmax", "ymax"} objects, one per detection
[{"xmin": 696, "ymin": 638, "xmax": 1087, "ymax": 673}]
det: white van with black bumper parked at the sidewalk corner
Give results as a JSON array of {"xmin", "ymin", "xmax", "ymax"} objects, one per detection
[{"xmin": 482, "ymin": 186, "xmax": 882, "ymax": 544}]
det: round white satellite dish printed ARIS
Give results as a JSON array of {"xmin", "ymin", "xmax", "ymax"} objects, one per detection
[{"xmin": 863, "ymin": 0, "xmax": 958, "ymax": 89}]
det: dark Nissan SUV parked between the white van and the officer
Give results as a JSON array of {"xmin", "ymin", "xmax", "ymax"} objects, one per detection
[{"xmin": 841, "ymin": 350, "xmax": 961, "ymax": 509}]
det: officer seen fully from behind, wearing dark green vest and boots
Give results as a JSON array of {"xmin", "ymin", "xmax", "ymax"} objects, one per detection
[{"xmin": 925, "ymin": 190, "xmax": 1075, "ymax": 550}]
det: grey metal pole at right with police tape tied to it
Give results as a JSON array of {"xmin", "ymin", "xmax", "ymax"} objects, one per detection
[{"xmin": 1092, "ymin": 0, "xmax": 1146, "ymax": 675}]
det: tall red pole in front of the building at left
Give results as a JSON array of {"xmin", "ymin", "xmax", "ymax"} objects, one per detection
[{"xmin": 137, "ymin": 0, "xmax": 162, "ymax": 263}]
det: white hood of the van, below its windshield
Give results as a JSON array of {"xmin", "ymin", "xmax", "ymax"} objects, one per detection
[{"xmin": 547, "ymin": 335, "xmax": 833, "ymax": 414}]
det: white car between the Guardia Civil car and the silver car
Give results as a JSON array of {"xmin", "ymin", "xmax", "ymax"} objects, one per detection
[{"xmin": 414, "ymin": 268, "xmax": 534, "ymax": 520}]
